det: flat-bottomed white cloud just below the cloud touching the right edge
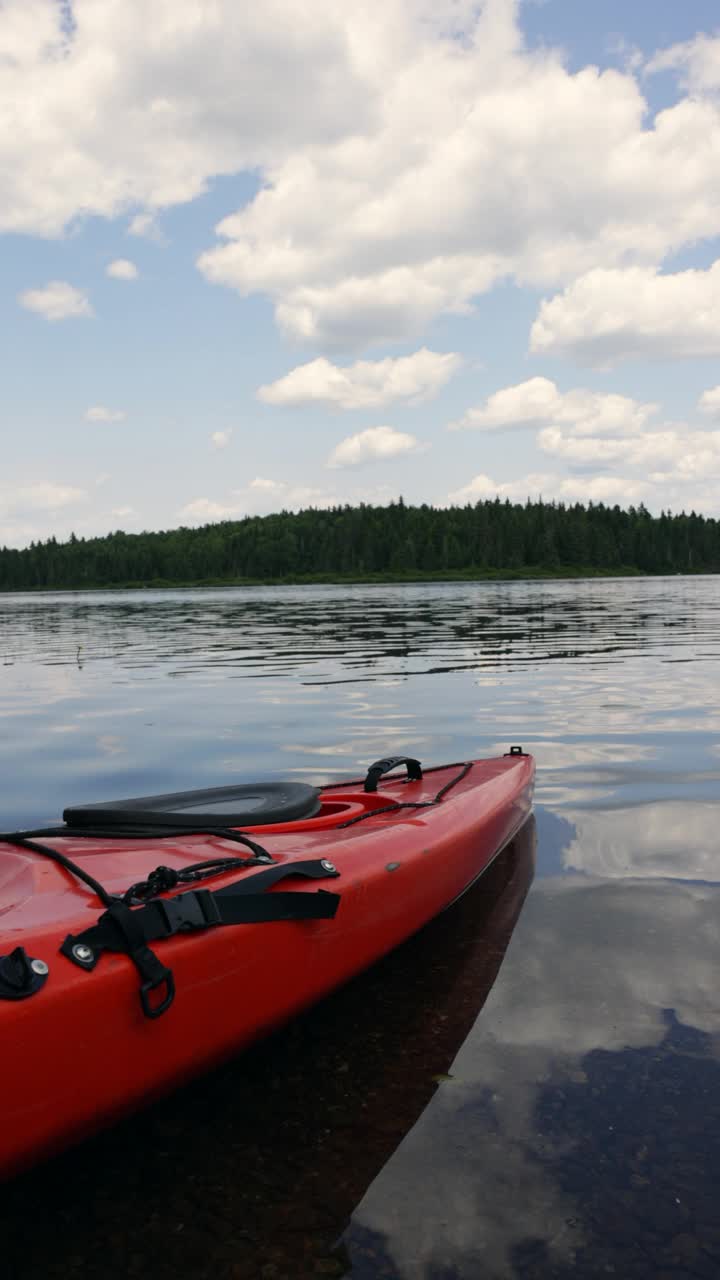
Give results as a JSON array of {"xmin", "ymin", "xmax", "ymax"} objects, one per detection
[{"xmin": 450, "ymin": 378, "xmax": 657, "ymax": 435}]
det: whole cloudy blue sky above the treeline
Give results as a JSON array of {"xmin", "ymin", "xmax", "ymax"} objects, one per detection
[{"xmin": 0, "ymin": 0, "xmax": 720, "ymax": 545}]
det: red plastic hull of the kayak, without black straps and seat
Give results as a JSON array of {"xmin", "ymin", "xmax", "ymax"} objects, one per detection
[{"xmin": 0, "ymin": 755, "xmax": 534, "ymax": 1176}]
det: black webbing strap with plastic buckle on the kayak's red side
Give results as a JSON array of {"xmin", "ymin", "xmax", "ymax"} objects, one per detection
[{"xmin": 60, "ymin": 859, "xmax": 340, "ymax": 1018}]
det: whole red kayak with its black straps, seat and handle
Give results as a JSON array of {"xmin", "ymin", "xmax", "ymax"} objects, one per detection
[{"xmin": 0, "ymin": 748, "xmax": 534, "ymax": 1175}]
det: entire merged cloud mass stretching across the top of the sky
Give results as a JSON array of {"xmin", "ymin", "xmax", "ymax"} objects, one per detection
[{"xmin": 0, "ymin": 0, "xmax": 720, "ymax": 349}]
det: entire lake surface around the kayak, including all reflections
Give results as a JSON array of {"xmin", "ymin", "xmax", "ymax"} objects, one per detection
[{"xmin": 0, "ymin": 577, "xmax": 720, "ymax": 1280}]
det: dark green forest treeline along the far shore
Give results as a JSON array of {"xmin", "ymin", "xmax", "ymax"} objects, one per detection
[{"xmin": 0, "ymin": 499, "xmax": 720, "ymax": 590}]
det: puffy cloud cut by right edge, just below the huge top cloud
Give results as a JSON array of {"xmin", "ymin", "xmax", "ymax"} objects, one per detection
[{"xmin": 530, "ymin": 261, "xmax": 720, "ymax": 366}]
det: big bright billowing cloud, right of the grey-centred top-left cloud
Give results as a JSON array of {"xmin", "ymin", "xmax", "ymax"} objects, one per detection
[{"xmin": 199, "ymin": 0, "xmax": 720, "ymax": 349}]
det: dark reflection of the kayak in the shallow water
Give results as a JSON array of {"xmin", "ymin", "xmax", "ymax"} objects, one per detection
[{"xmin": 0, "ymin": 818, "xmax": 536, "ymax": 1280}]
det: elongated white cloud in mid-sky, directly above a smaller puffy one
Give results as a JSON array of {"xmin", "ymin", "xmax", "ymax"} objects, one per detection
[{"xmin": 258, "ymin": 347, "xmax": 461, "ymax": 410}]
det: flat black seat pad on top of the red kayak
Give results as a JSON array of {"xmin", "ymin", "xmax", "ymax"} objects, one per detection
[{"xmin": 63, "ymin": 782, "xmax": 320, "ymax": 828}]
